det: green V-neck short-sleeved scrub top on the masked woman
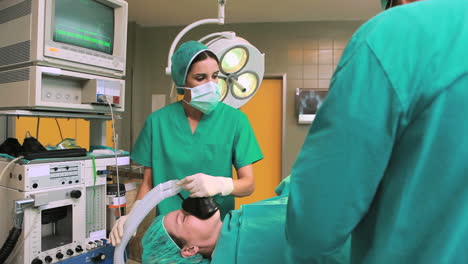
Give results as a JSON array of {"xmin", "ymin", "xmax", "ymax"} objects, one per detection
[{"xmin": 131, "ymin": 101, "xmax": 263, "ymax": 219}]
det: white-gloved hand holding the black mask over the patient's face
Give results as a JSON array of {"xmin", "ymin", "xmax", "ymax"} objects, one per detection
[{"xmin": 177, "ymin": 173, "xmax": 234, "ymax": 197}]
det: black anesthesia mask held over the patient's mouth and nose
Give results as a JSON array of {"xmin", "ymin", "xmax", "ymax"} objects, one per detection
[{"xmin": 178, "ymin": 193, "xmax": 219, "ymax": 220}]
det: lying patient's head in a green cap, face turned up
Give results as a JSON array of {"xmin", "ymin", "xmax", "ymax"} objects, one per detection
[{"xmin": 142, "ymin": 210, "xmax": 222, "ymax": 263}]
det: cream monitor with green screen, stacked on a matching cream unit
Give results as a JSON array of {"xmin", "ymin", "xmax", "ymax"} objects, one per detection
[{"xmin": 0, "ymin": 0, "xmax": 128, "ymax": 113}]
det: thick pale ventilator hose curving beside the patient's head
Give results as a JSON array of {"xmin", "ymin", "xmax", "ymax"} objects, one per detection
[{"xmin": 114, "ymin": 180, "xmax": 180, "ymax": 264}]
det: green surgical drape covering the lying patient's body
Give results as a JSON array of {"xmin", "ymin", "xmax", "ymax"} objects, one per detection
[{"xmin": 211, "ymin": 178, "xmax": 349, "ymax": 264}]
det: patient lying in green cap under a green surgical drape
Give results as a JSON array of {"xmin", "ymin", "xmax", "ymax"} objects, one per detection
[{"xmin": 142, "ymin": 177, "xmax": 349, "ymax": 264}]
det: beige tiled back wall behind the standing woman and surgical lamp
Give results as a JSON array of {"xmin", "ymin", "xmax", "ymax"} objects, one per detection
[{"xmin": 131, "ymin": 21, "xmax": 364, "ymax": 175}]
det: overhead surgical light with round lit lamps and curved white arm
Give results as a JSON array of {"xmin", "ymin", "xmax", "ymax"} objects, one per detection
[{"xmin": 166, "ymin": 0, "xmax": 265, "ymax": 108}]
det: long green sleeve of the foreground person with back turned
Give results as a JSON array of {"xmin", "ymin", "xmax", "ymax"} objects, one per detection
[{"xmin": 286, "ymin": 42, "xmax": 401, "ymax": 263}]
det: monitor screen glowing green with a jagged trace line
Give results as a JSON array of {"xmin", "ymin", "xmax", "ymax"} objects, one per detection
[{"xmin": 53, "ymin": 0, "xmax": 114, "ymax": 55}]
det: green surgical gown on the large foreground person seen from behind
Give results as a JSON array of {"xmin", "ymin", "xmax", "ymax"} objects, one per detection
[{"xmin": 286, "ymin": 0, "xmax": 468, "ymax": 264}]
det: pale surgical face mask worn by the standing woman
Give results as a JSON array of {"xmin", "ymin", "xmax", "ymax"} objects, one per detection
[{"xmin": 180, "ymin": 82, "xmax": 221, "ymax": 114}]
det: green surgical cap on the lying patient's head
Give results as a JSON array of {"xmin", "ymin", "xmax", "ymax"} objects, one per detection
[{"xmin": 141, "ymin": 215, "xmax": 210, "ymax": 264}]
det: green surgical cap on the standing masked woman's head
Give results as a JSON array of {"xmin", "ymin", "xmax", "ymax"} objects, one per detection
[{"xmin": 171, "ymin": 40, "xmax": 208, "ymax": 94}]
